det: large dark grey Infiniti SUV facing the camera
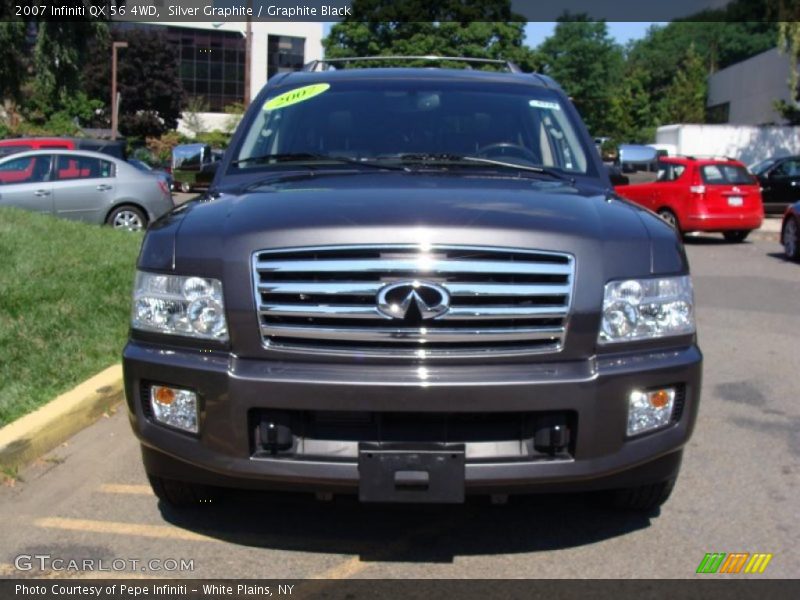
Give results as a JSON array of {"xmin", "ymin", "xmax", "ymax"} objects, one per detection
[{"xmin": 124, "ymin": 56, "xmax": 702, "ymax": 510}]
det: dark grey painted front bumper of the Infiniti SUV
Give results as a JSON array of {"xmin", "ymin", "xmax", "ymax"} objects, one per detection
[{"xmin": 123, "ymin": 341, "xmax": 702, "ymax": 493}]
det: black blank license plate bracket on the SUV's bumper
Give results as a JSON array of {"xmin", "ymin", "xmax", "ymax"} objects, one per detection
[{"xmin": 358, "ymin": 442, "xmax": 466, "ymax": 504}]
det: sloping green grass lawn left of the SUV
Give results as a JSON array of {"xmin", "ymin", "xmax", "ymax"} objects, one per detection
[{"xmin": 0, "ymin": 208, "xmax": 142, "ymax": 427}]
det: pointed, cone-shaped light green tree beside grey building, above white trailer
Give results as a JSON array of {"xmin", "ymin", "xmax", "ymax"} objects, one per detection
[{"xmin": 661, "ymin": 44, "xmax": 708, "ymax": 123}]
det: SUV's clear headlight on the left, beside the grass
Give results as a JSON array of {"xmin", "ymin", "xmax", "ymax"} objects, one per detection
[{"xmin": 131, "ymin": 271, "xmax": 228, "ymax": 341}]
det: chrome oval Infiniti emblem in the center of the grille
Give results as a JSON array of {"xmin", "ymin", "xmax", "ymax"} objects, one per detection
[{"xmin": 377, "ymin": 281, "xmax": 450, "ymax": 321}]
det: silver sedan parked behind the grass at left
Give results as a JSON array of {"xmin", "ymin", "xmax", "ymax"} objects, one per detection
[{"xmin": 0, "ymin": 150, "xmax": 174, "ymax": 231}]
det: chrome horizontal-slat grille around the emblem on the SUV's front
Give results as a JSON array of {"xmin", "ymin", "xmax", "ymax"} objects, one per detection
[{"xmin": 253, "ymin": 245, "xmax": 575, "ymax": 356}]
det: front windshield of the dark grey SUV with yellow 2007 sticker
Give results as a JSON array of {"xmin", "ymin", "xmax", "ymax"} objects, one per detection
[{"xmin": 232, "ymin": 80, "xmax": 590, "ymax": 174}]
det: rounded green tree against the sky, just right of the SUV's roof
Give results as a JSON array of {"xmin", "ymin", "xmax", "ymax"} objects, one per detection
[{"xmin": 539, "ymin": 14, "xmax": 624, "ymax": 135}]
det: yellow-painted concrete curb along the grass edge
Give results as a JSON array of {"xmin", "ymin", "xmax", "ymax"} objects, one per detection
[{"xmin": 0, "ymin": 364, "xmax": 125, "ymax": 469}]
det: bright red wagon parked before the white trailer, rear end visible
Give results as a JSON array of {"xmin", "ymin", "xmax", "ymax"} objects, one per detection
[{"xmin": 614, "ymin": 156, "xmax": 764, "ymax": 242}]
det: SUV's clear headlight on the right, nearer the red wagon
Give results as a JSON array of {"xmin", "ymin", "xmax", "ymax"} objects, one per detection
[{"xmin": 599, "ymin": 275, "xmax": 695, "ymax": 344}]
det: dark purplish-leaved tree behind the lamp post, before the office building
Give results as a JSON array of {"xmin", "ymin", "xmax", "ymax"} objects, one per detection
[{"xmin": 83, "ymin": 29, "xmax": 184, "ymax": 139}]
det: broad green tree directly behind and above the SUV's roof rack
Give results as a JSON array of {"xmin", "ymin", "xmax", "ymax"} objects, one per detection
[{"xmin": 323, "ymin": 0, "xmax": 538, "ymax": 71}]
